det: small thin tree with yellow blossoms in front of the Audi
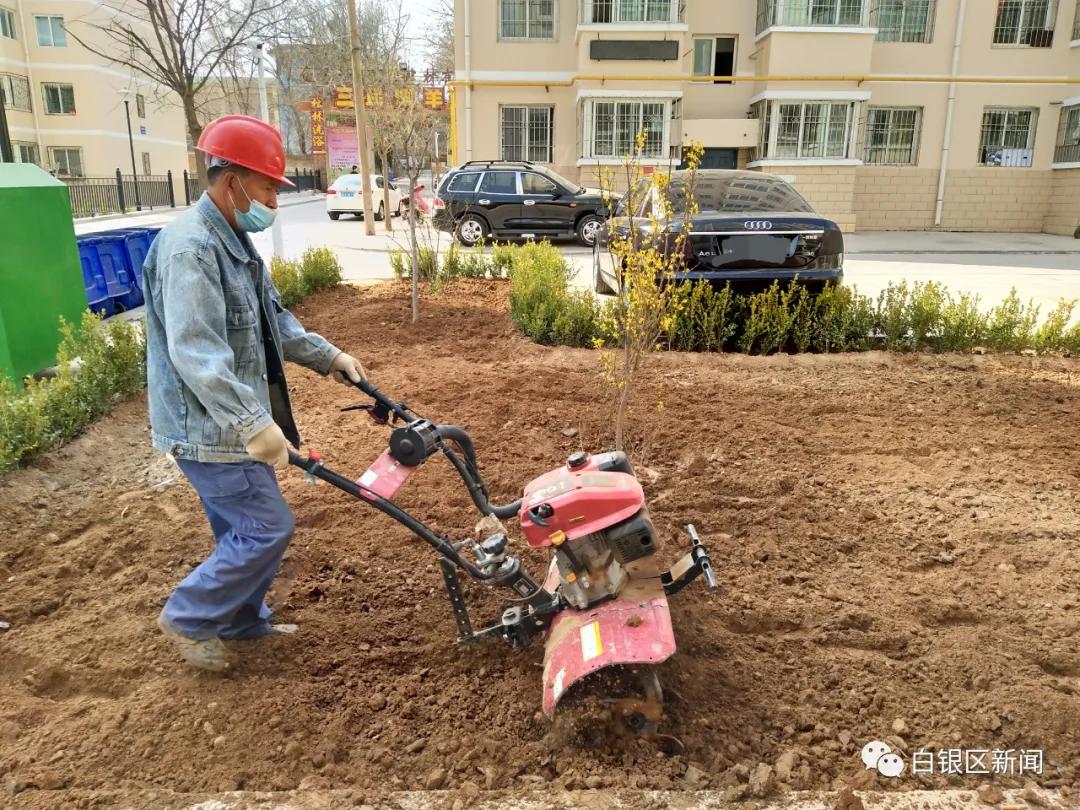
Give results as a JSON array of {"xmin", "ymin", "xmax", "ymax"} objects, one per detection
[{"xmin": 596, "ymin": 140, "xmax": 703, "ymax": 450}]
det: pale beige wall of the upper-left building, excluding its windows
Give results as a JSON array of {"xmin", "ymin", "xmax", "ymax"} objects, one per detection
[{"xmin": 0, "ymin": 0, "xmax": 187, "ymax": 176}]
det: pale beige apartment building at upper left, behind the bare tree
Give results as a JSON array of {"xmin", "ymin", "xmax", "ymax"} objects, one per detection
[{"xmin": 0, "ymin": 0, "xmax": 187, "ymax": 178}]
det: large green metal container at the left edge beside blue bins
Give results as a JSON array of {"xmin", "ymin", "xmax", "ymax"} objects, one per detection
[{"xmin": 0, "ymin": 163, "xmax": 86, "ymax": 379}]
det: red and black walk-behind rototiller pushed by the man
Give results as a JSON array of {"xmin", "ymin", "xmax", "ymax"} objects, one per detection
[{"xmin": 289, "ymin": 382, "xmax": 716, "ymax": 750}]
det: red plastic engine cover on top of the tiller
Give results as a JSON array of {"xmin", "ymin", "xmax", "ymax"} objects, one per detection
[{"xmin": 518, "ymin": 459, "xmax": 645, "ymax": 549}]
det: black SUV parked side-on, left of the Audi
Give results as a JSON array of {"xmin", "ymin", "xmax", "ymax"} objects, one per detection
[{"xmin": 432, "ymin": 160, "xmax": 608, "ymax": 247}]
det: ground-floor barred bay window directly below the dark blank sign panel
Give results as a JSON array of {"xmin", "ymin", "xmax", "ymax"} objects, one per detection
[{"xmin": 582, "ymin": 100, "xmax": 671, "ymax": 159}]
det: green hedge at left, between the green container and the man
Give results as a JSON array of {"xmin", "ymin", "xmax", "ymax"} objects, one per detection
[{"xmin": 0, "ymin": 312, "xmax": 146, "ymax": 472}]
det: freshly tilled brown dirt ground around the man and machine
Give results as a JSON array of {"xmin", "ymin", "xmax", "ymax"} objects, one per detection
[{"xmin": 0, "ymin": 282, "xmax": 1080, "ymax": 808}]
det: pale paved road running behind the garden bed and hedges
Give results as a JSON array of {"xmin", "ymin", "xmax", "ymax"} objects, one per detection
[{"xmin": 77, "ymin": 198, "xmax": 1080, "ymax": 311}]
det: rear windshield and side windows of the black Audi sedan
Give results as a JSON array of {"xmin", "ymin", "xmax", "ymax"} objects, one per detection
[{"xmin": 620, "ymin": 175, "xmax": 813, "ymax": 216}]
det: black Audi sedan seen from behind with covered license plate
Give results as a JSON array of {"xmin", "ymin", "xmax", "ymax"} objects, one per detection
[{"xmin": 593, "ymin": 170, "xmax": 843, "ymax": 294}]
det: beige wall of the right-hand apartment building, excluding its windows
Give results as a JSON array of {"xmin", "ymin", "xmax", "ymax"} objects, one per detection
[{"xmin": 456, "ymin": 0, "xmax": 1080, "ymax": 233}]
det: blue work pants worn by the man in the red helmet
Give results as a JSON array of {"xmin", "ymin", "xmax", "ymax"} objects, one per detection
[{"xmin": 165, "ymin": 459, "xmax": 294, "ymax": 639}]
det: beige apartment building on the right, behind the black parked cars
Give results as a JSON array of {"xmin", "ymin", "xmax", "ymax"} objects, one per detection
[{"xmin": 454, "ymin": 0, "xmax": 1080, "ymax": 234}]
